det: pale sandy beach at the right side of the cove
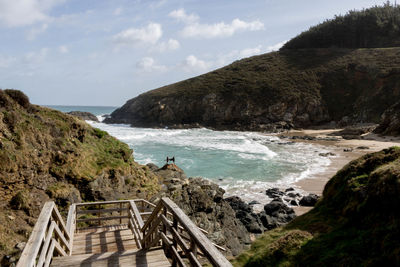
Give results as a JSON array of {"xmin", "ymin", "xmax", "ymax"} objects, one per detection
[{"xmin": 282, "ymin": 129, "xmax": 400, "ymax": 215}]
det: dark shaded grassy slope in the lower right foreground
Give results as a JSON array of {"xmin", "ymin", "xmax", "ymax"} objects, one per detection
[{"xmin": 235, "ymin": 147, "xmax": 400, "ymax": 266}]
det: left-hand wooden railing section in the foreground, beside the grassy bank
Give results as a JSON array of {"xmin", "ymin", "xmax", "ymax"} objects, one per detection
[{"xmin": 17, "ymin": 202, "xmax": 73, "ymax": 267}]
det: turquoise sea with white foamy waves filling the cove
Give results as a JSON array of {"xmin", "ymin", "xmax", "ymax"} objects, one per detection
[{"xmin": 49, "ymin": 106, "xmax": 331, "ymax": 207}]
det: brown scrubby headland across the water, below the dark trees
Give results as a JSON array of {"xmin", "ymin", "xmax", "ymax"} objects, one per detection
[{"xmin": 106, "ymin": 48, "xmax": 400, "ymax": 131}]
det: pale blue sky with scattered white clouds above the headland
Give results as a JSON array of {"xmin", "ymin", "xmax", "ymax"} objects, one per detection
[{"xmin": 0, "ymin": 0, "xmax": 394, "ymax": 106}]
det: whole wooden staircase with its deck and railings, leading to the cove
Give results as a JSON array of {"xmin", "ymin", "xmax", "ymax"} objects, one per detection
[{"xmin": 17, "ymin": 198, "xmax": 232, "ymax": 267}]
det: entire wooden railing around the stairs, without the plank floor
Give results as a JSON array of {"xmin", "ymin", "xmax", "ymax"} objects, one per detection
[{"xmin": 17, "ymin": 198, "xmax": 232, "ymax": 267}]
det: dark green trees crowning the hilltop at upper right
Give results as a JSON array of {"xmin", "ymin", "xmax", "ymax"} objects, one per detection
[{"xmin": 282, "ymin": 1, "xmax": 400, "ymax": 50}]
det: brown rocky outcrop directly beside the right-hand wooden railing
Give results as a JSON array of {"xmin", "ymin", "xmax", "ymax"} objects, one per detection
[{"xmin": 152, "ymin": 164, "xmax": 251, "ymax": 255}]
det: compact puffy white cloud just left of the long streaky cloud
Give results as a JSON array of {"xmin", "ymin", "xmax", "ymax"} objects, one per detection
[{"xmin": 113, "ymin": 23, "xmax": 162, "ymax": 45}]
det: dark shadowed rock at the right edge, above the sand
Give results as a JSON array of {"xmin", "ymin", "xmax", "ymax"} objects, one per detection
[{"xmin": 375, "ymin": 101, "xmax": 400, "ymax": 135}]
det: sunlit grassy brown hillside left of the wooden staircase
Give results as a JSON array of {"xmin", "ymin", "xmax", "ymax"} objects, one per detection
[{"xmin": 0, "ymin": 90, "xmax": 160, "ymax": 266}]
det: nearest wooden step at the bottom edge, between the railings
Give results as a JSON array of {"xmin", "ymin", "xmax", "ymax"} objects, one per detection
[{"xmin": 50, "ymin": 248, "xmax": 171, "ymax": 267}]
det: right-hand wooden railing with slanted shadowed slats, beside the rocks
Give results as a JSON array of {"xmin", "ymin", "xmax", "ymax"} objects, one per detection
[{"xmin": 141, "ymin": 198, "xmax": 232, "ymax": 267}]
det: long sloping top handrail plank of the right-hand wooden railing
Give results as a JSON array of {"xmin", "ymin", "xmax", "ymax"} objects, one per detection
[{"xmin": 161, "ymin": 197, "xmax": 232, "ymax": 266}]
